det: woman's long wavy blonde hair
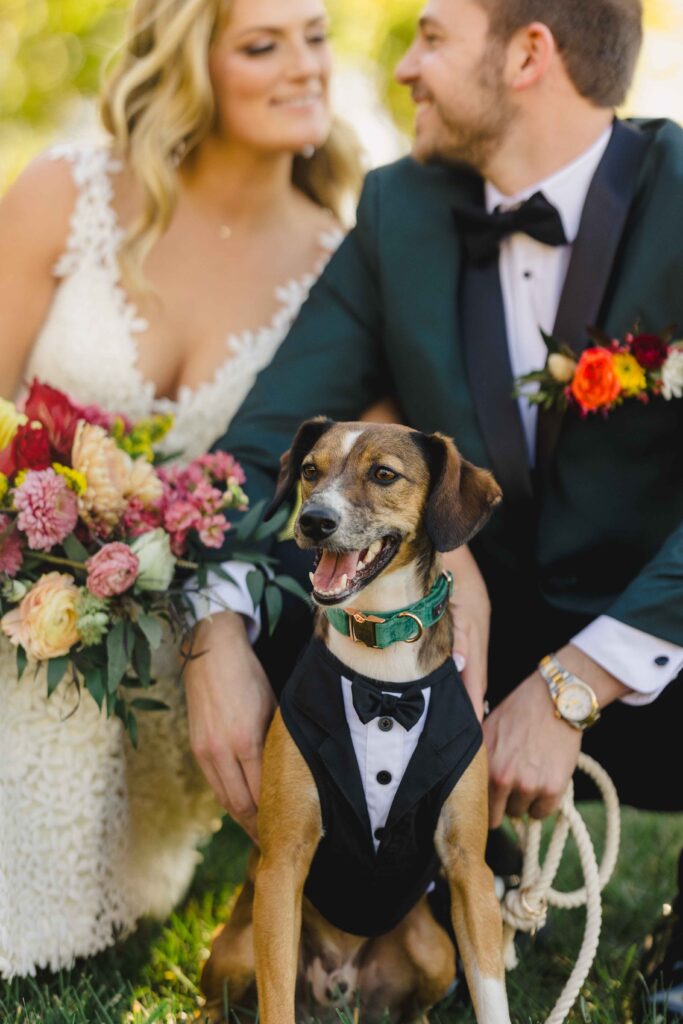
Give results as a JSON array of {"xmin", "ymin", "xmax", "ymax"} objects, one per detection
[{"xmin": 101, "ymin": 0, "xmax": 361, "ymax": 287}]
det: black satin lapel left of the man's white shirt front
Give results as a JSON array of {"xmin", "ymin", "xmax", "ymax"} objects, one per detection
[{"xmin": 460, "ymin": 260, "xmax": 531, "ymax": 503}]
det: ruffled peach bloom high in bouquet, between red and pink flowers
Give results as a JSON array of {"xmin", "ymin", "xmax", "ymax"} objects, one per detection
[{"xmin": 72, "ymin": 420, "xmax": 163, "ymax": 534}]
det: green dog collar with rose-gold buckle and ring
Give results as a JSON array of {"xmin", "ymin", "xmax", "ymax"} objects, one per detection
[{"xmin": 325, "ymin": 571, "xmax": 453, "ymax": 649}]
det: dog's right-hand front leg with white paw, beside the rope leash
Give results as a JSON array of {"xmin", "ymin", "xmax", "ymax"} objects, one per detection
[{"xmin": 434, "ymin": 746, "xmax": 510, "ymax": 1024}]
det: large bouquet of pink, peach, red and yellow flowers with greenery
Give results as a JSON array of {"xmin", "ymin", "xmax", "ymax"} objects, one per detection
[{"xmin": 0, "ymin": 381, "xmax": 303, "ymax": 742}]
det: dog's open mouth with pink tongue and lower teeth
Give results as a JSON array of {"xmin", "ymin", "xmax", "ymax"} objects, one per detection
[{"xmin": 310, "ymin": 534, "xmax": 400, "ymax": 604}]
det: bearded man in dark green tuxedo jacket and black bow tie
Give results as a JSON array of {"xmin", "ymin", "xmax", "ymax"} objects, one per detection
[{"xmin": 188, "ymin": 0, "xmax": 683, "ymax": 1007}]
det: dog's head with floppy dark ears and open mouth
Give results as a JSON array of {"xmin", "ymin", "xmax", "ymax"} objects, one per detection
[{"xmin": 266, "ymin": 418, "xmax": 501, "ymax": 605}]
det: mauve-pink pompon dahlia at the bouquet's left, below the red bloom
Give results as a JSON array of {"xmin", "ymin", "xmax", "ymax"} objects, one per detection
[{"xmin": 13, "ymin": 469, "xmax": 78, "ymax": 551}]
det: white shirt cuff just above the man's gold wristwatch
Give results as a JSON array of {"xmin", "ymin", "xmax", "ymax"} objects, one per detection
[{"xmin": 571, "ymin": 615, "xmax": 683, "ymax": 705}]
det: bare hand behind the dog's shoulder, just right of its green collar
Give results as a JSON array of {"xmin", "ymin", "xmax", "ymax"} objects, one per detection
[{"xmin": 442, "ymin": 546, "xmax": 490, "ymax": 721}]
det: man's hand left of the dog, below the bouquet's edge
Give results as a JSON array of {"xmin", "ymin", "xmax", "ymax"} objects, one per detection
[{"xmin": 184, "ymin": 611, "xmax": 275, "ymax": 841}]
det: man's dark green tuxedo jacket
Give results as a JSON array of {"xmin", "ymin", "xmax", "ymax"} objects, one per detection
[{"xmin": 219, "ymin": 121, "xmax": 683, "ymax": 663}]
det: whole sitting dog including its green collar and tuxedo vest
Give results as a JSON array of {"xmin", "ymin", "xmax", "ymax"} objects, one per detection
[{"xmin": 202, "ymin": 418, "xmax": 510, "ymax": 1024}]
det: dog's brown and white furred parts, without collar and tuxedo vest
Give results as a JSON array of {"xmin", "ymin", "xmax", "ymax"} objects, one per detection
[{"xmin": 202, "ymin": 419, "xmax": 510, "ymax": 1024}]
